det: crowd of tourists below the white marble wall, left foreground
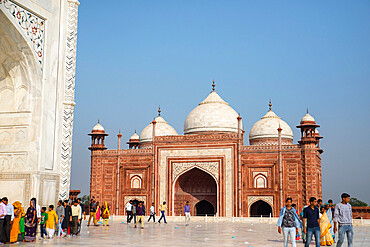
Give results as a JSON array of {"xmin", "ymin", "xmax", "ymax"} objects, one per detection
[{"xmin": 0, "ymin": 197, "xmax": 92, "ymax": 244}]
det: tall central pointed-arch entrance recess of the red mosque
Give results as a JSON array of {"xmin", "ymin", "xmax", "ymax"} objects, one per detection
[{"xmin": 174, "ymin": 167, "xmax": 217, "ymax": 215}]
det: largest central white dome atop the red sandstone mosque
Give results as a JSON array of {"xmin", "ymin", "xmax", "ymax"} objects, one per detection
[{"xmin": 184, "ymin": 91, "xmax": 243, "ymax": 134}]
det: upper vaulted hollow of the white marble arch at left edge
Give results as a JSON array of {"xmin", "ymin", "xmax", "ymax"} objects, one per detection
[{"xmin": 0, "ymin": 10, "xmax": 42, "ymax": 114}]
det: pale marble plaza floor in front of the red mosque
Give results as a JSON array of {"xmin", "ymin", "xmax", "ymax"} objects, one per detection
[{"xmin": 5, "ymin": 221, "xmax": 370, "ymax": 247}]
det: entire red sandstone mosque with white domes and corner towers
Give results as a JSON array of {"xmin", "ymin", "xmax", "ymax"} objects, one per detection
[{"xmin": 89, "ymin": 83, "xmax": 323, "ymax": 217}]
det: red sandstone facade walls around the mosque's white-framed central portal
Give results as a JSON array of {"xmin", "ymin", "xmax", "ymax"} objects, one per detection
[{"xmin": 90, "ymin": 135, "xmax": 322, "ymax": 216}]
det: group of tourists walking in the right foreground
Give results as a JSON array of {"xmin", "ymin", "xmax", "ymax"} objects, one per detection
[{"xmin": 277, "ymin": 193, "xmax": 353, "ymax": 247}]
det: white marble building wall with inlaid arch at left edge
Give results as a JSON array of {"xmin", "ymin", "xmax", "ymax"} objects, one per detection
[{"xmin": 0, "ymin": 0, "xmax": 79, "ymax": 205}]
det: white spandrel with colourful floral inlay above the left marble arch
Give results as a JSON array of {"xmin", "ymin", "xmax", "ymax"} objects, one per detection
[{"xmin": 0, "ymin": 0, "xmax": 45, "ymax": 70}]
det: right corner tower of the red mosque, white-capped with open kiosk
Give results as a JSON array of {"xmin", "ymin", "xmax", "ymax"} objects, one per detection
[{"xmin": 297, "ymin": 109, "xmax": 323, "ymax": 204}]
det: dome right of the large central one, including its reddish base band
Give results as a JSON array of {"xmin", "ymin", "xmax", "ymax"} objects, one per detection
[{"xmin": 249, "ymin": 109, "xmax": 293, "ymax": 145}]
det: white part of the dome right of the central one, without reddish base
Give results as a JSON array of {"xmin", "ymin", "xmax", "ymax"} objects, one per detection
[{"xmin": 249, "ymin": 110, "xmax": 293, "ymax": 140}]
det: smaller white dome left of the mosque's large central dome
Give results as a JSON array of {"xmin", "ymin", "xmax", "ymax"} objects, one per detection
[{"xmin": 140, "ymin": 116, "xmax": 178, "ymax": 143}]
